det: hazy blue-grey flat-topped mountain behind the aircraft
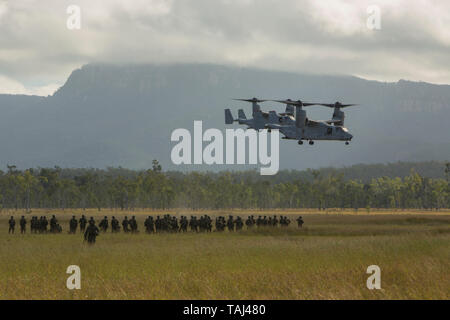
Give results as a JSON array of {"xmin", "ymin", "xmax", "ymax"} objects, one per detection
[{"xmin": 0, "ymin": 64, "xmax": 450, "ymax": 170}]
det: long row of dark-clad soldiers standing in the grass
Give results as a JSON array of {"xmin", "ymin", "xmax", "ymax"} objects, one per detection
[{"xmin": 8, "ymin": 214, "xmax": 304, "ymax": 239}]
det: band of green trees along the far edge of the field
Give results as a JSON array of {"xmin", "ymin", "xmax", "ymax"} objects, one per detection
[{"xmin": 0, "ymin": 160, "xmax": 450, "ymax": 211}]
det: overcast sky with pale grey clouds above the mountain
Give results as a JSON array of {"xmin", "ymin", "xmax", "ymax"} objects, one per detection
[{"xmin": 0, "ymin": 0, "xmax": 450, "ymax": 95}]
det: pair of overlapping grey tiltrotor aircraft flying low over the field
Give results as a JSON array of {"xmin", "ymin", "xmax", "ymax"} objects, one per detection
[{"xmin": 225, "ymin": 98, "xmax": 355, "ymax": 145}]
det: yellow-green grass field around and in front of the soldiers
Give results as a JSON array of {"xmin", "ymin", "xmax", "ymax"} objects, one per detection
[{"xmin": 0, "ymin": 210, "xmax": 450, "ymax": 299}]
